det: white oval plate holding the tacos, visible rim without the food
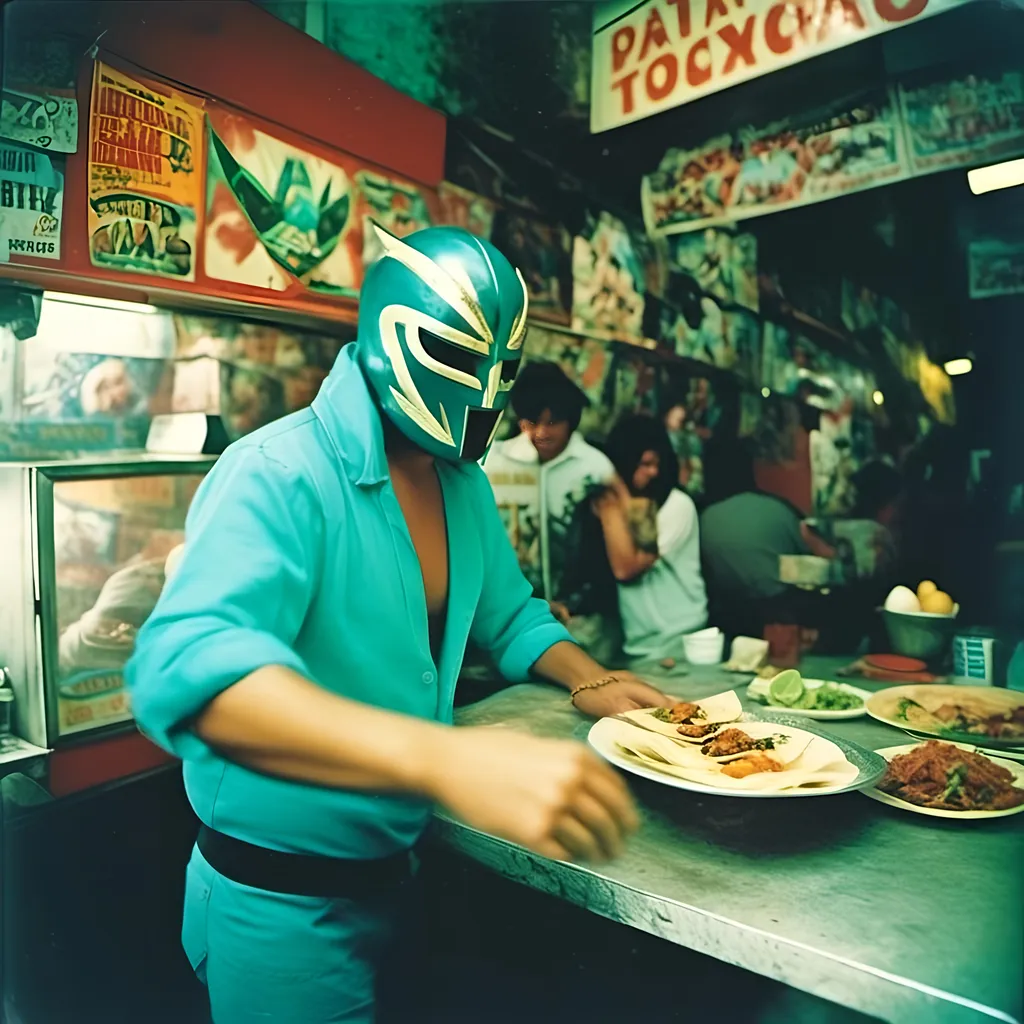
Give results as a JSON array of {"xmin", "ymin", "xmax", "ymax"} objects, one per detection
[{"xmin": 587, "ymin": 718, "xmax": 885, "ymax": 799}]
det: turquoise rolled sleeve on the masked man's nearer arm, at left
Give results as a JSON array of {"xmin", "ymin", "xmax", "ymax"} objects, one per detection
[{"xmin": 125, "ymin": 446, "xmax": 323, "ymax": 757}]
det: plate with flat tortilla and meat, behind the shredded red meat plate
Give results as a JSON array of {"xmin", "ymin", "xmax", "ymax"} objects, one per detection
[{"xmin": 866, "ymin": 684, "xmax": 1024, "ymax": 750}]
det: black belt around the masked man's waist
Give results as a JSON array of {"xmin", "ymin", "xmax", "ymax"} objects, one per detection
[{"xmin": 198, "ymin": 825, "xmax": 413, "ymax": 899}]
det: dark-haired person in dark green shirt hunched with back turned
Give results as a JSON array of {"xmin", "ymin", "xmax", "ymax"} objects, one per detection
[{"xmin": 700, "ymin": 438, "xmax": 833, "ymax": 637}]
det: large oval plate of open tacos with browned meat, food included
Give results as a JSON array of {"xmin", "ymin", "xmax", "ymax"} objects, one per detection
[{"xmin": 587, "ymin": 691, "xmax": 886, "ymax": 797}]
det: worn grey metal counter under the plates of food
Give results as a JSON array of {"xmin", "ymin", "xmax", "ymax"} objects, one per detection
[{"xmin": 438, "ymin": 669, "xmax": 1024, "ymax": 1024}]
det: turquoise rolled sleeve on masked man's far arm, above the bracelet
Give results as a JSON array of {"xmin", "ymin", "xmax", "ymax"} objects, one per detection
[{"xmin": 470, "ymin": 473, "xmax": 574, "ymax": 683}]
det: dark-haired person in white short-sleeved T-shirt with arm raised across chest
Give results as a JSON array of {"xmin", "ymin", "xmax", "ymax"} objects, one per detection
[{"xmin": 595, "ymin": 416, "xmax": 708, "ymax": 659}]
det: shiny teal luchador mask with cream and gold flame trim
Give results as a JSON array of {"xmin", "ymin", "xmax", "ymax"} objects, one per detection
[{"xmin": 357, "ymin": 224, "xmax": 526, "ymax": 462}]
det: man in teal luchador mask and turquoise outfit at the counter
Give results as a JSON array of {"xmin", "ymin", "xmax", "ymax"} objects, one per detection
[{"xmin": 127, "ymin": 227, "xmax": 666, "ymax": 1024}]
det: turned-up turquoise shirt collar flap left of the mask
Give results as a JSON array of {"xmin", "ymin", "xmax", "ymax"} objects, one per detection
[{"xmin": 312, "ymin": 344, "xmax": 388, "ymax": 487}]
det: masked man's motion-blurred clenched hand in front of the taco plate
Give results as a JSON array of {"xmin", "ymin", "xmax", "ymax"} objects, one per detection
[{"xmin": 427, "ymin": 728, "xmax": 638, "ymax": 861}]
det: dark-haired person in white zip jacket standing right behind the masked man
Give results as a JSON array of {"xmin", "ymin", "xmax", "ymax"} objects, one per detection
[{"xmin": 483, "ymin": 362, "xmax": 621, "ymax": 660}]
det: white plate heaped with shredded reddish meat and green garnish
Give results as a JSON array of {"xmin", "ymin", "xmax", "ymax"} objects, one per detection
[{"xmin": 864, "ymin": 739, "xmax": 1024, "ymax": 820}]
